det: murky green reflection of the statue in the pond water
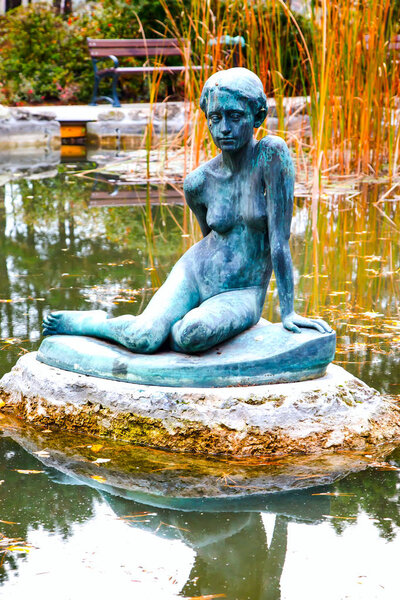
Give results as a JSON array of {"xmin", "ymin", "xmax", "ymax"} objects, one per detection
[{"xmin": 103, "ymin": 490, "xmax": 330, "ymax": 600}]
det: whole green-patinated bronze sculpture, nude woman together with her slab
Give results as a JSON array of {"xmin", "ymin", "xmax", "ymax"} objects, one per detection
[{"xmin": 39, "ymin": 68, "xmax": 335, "ymax": 387}]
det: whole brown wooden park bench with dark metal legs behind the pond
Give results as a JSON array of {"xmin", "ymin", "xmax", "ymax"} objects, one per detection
[{"xmin": 87, "ymin": 38, "xmax": 202, "ymax": 106}]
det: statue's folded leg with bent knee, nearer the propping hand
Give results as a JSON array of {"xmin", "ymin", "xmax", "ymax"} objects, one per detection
[{"xmin": 171, "ymin": 287, "xmax": 265, "ymax": 353}]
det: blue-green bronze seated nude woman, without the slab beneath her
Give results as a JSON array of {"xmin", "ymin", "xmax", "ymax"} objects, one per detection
[{"xmin": 44, "ymin": 68, "xmax": 331, "ymax": 354}]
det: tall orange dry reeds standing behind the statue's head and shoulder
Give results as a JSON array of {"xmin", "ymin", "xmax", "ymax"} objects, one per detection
[{"xmin": 161, "ymin": 0, "xmax": 400, "ymax": 184}]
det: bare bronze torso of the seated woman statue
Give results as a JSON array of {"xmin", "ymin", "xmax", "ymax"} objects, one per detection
[{"xmin": 185, "ymin": 144, "xmax": 270, "ymax": 300}]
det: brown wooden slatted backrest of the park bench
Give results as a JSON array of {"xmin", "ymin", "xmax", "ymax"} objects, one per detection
[{"xmin": 87, "ymin": 38, "xmax": 188, "ymax": 58}]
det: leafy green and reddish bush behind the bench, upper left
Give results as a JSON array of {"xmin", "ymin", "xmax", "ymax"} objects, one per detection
[{"xmin": 0, "ymin": 0, "xmax": 186, "ymax": 104}]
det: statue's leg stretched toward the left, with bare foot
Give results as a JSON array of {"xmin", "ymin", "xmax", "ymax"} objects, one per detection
[{"xmin": 43, "ymin": 261, "xmax": 199, "ymax": 353}]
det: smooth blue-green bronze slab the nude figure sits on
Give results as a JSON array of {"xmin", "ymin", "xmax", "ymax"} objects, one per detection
[{"xmin": 38, "ymin": 322, "xmax": 336, "ymax": 387}]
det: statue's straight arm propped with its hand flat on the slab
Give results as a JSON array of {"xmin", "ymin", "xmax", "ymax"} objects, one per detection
[{"xmin": 264, "ymin": 137, "xmax": 331, "ymax": 333}]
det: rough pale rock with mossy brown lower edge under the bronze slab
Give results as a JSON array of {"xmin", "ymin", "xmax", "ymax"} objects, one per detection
[{"xmin": 0, "ymin": 353, "xmax": 400, "ymax": 456}]
